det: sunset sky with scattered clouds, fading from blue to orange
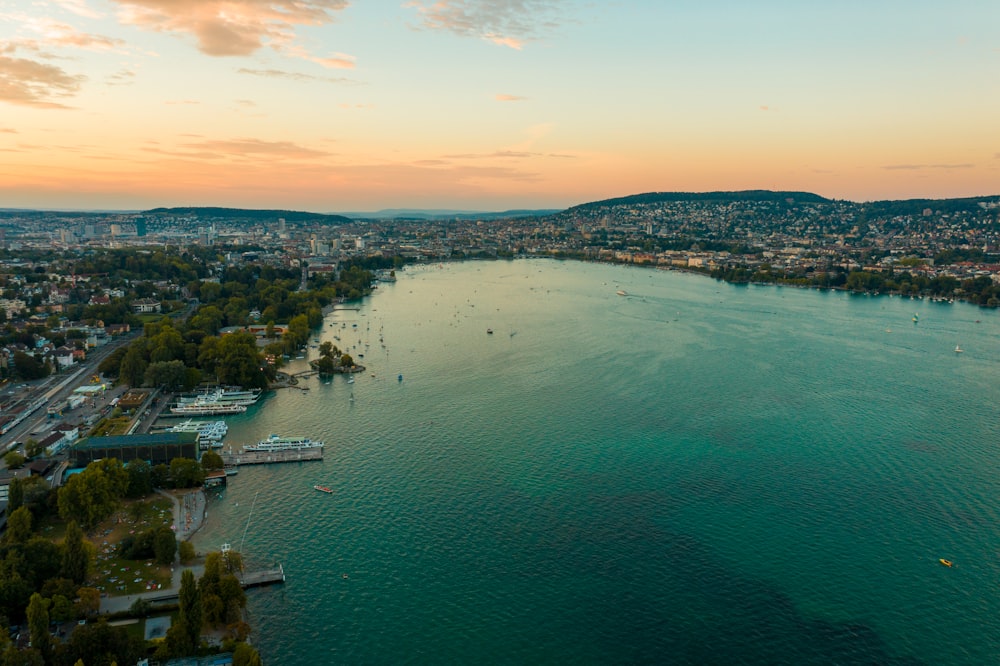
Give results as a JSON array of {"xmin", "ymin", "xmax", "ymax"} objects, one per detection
[{"xmin": 0, "ymin": 0, "xmax": 1000, "ymax": 212}]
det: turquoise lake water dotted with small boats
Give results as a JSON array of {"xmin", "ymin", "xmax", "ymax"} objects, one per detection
[{"xmin": 196, "ymin": 260, "xmax": 1000, "ymax": 666}]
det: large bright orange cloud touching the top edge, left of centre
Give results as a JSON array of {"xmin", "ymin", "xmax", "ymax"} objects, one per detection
[{"xmin": 115, "ymin": 0, "xmax": 354, "ymax": 69}]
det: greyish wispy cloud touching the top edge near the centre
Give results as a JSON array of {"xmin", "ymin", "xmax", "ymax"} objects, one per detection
[{"xmin": 404, "ymin": 0, "xmax": 562, "ymax": 50}]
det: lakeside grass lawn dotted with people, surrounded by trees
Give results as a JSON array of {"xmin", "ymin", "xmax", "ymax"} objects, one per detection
[{"xmin": 87, "ymin": 496, "xmax": 174, "ymax": 596}]
